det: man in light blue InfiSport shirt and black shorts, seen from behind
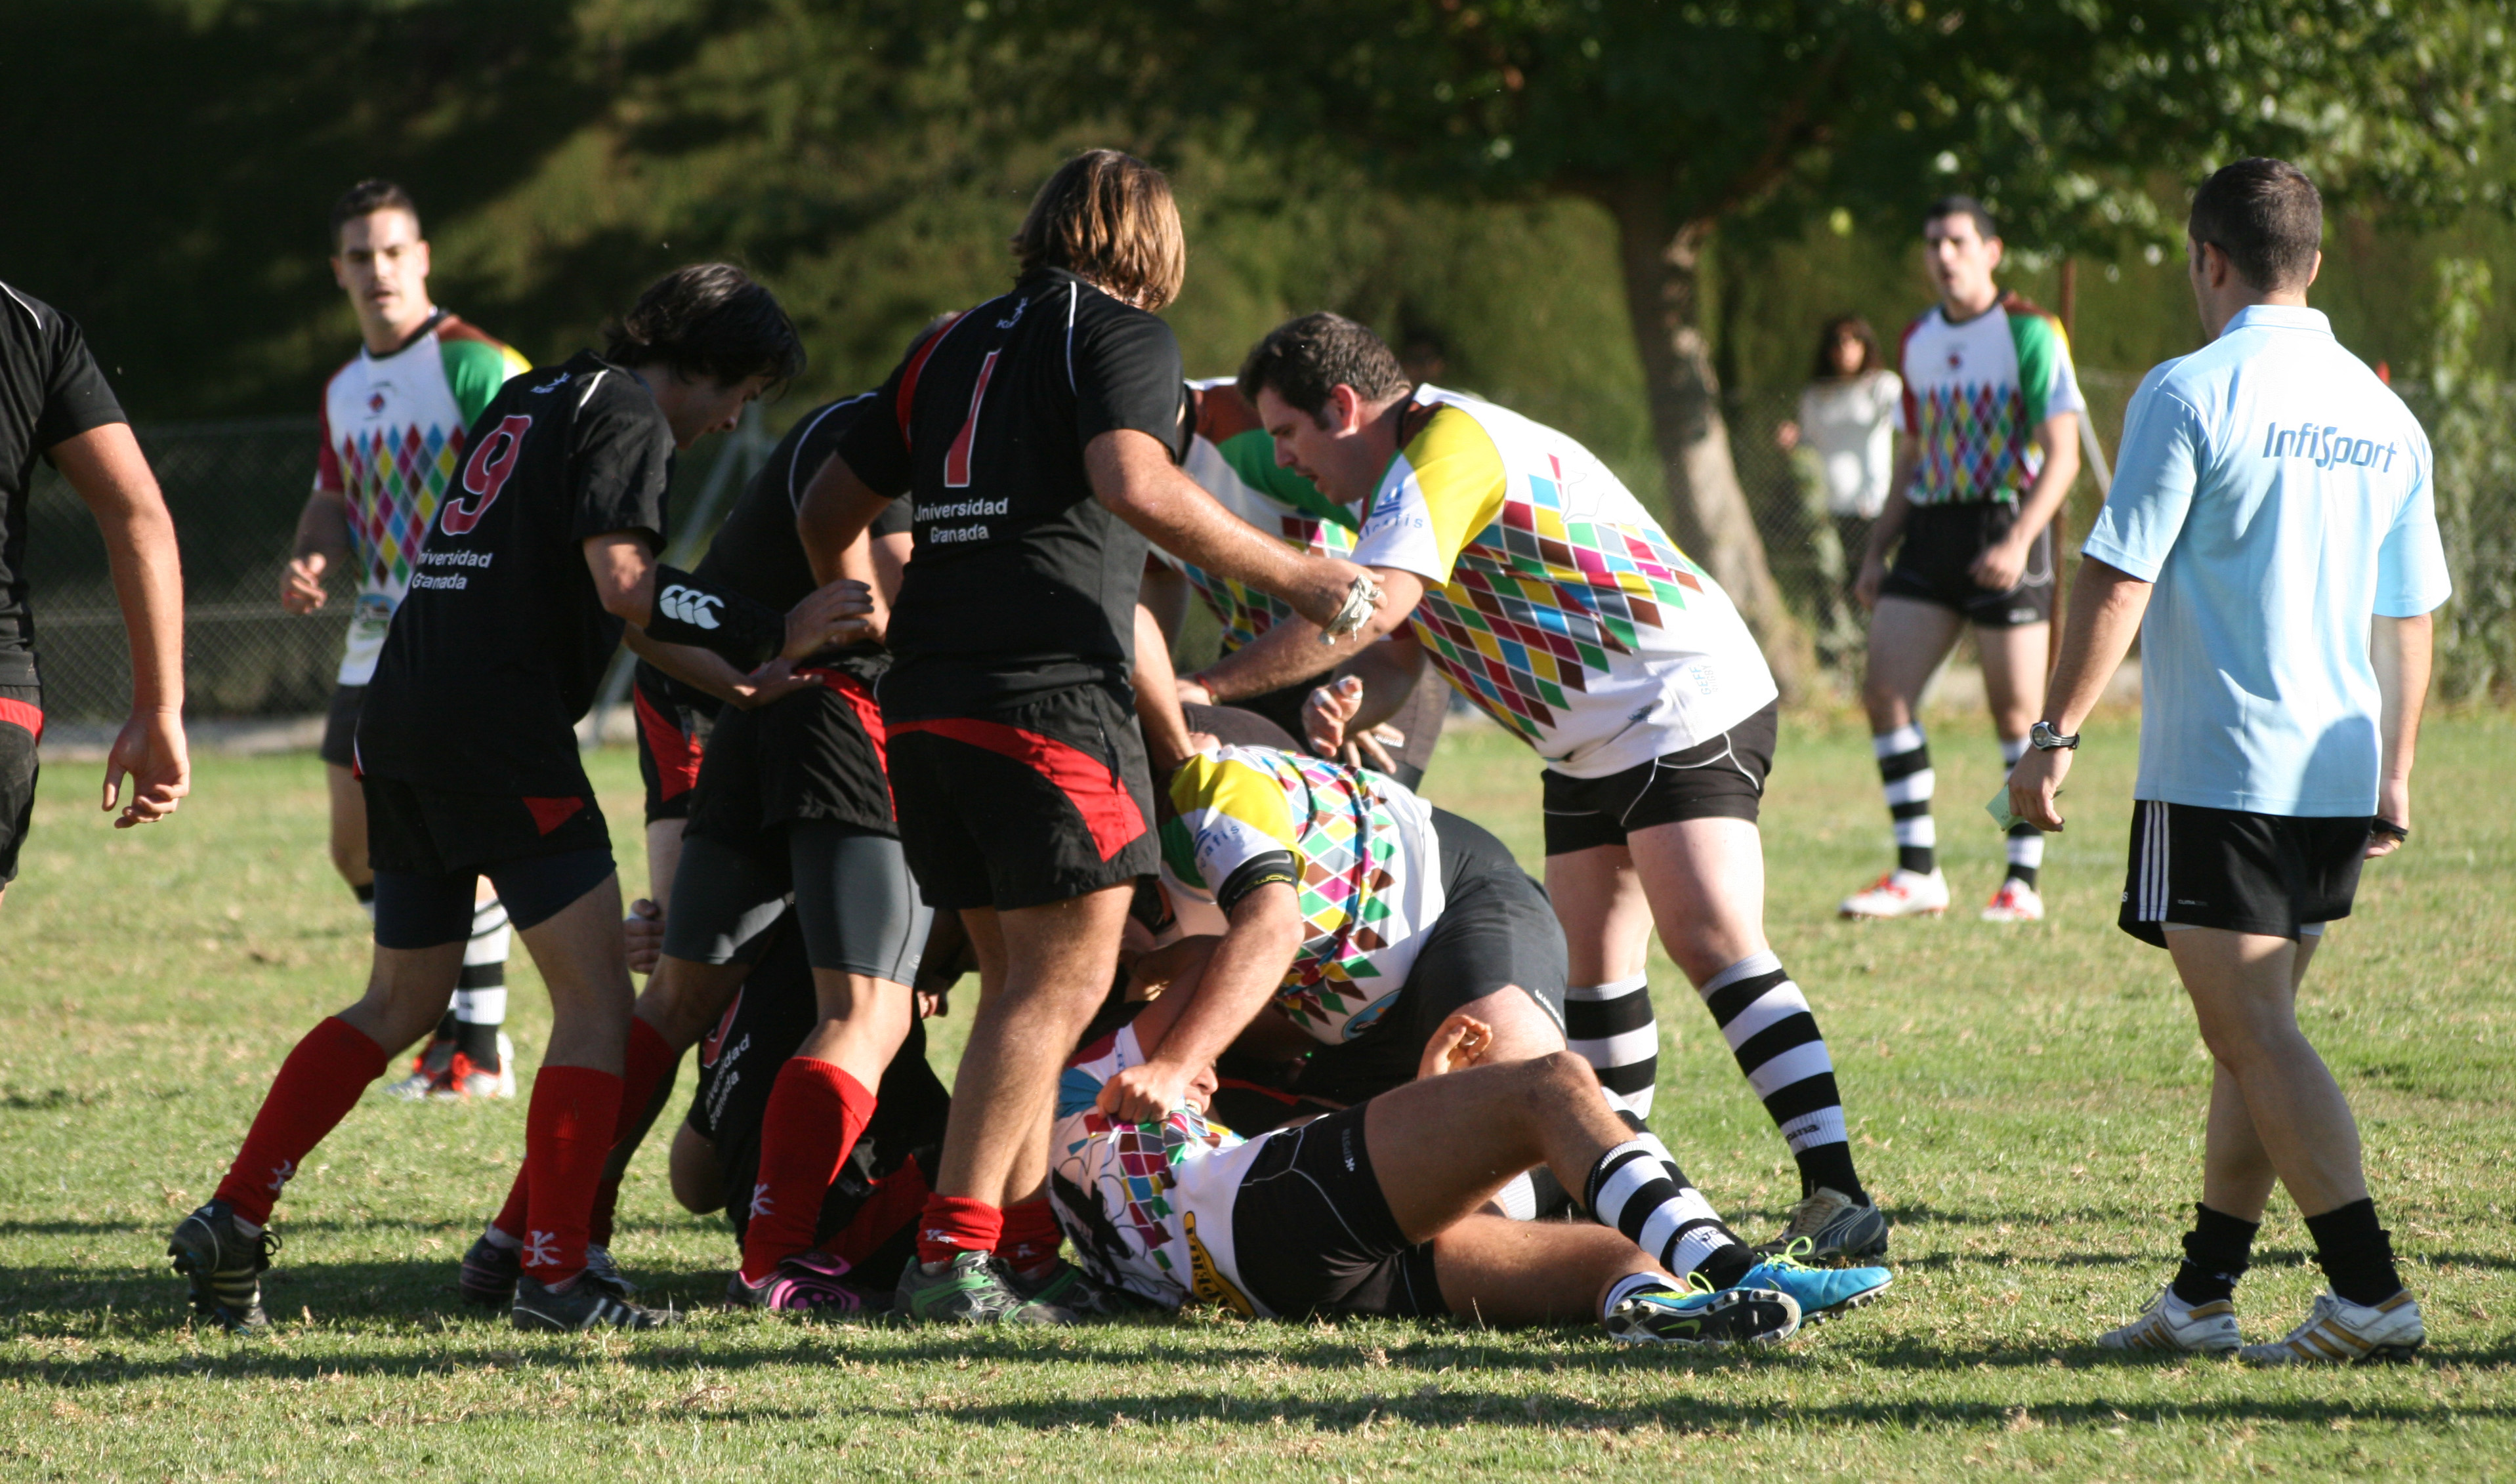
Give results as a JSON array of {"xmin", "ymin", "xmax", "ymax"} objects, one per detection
[{"xmin": 2010, "ymin": 159, "xmax": 2448, "ymax": 1366}]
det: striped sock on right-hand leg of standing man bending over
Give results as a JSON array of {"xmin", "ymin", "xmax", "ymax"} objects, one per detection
[{"xmin": 1698, "ymin": 951, "xmax": 1870, "ymax": 1200}]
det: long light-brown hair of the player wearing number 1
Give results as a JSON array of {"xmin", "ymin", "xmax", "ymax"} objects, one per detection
[{"xmin": 1014, "ymin": 148, "xmax": 1188, "ymax": 310}]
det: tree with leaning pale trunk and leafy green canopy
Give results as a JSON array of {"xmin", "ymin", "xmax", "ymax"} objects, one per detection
[{"xmin": 974, "ymin": 0, "xmax": 2508, "ymax": 689}]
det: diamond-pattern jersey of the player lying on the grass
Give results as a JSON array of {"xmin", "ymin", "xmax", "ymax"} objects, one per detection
[{"xmin": 1049, "ymin": 1023, "xmax": 1268, "ymax": 1315}]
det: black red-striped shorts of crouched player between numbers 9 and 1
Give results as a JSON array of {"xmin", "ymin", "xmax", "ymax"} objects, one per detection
[{"xmin": 682, "ymin": 667, "xmax": 898, "ymax": 848}]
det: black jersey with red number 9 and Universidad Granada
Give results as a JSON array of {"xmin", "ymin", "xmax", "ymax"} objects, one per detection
[{"xmin": 357, "ymin": 350, "xmax": 672, "ymax": 797}]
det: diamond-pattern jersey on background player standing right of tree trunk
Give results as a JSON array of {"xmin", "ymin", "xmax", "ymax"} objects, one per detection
[{"xmin": 1900, "ymin": 295, "xmax": 2088, "ymax": 506}]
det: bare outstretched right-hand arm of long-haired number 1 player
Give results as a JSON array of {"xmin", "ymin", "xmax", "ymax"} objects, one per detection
[{"xmin": 1084, "ymin": 428, "xmax": 1364, "ymax": 627}]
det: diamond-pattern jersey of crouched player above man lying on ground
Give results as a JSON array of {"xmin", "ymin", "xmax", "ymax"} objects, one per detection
[{"xmin": 1162, "ymin": 747, "xmax": 1442, "ymax": 1046}]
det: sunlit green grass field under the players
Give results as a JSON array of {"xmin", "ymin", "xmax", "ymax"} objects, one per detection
[{"xmin": 0, "ymin": 714, "xmax": 2516, "ymax": 1481}]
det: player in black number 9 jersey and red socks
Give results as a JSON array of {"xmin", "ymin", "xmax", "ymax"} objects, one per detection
[{"xmin": 169, "ymin": 264, "xmax": 871, "ymax": 1330}]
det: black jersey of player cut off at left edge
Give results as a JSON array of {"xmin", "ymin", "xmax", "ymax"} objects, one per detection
[{"xmin": 0, "ymin": 284, "xmax": 123, "ymax": 684}]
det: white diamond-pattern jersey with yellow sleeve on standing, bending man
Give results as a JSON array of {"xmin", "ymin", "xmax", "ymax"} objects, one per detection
[{"xmin": 1354, "ymin": 387, "xmax": 1776, "ymax": 777}]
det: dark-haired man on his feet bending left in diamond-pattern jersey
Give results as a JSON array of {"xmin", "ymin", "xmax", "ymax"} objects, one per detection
[{"xmin": 1180, "ymin": 314, "xmax": 1887, "ymax": 1260}]
